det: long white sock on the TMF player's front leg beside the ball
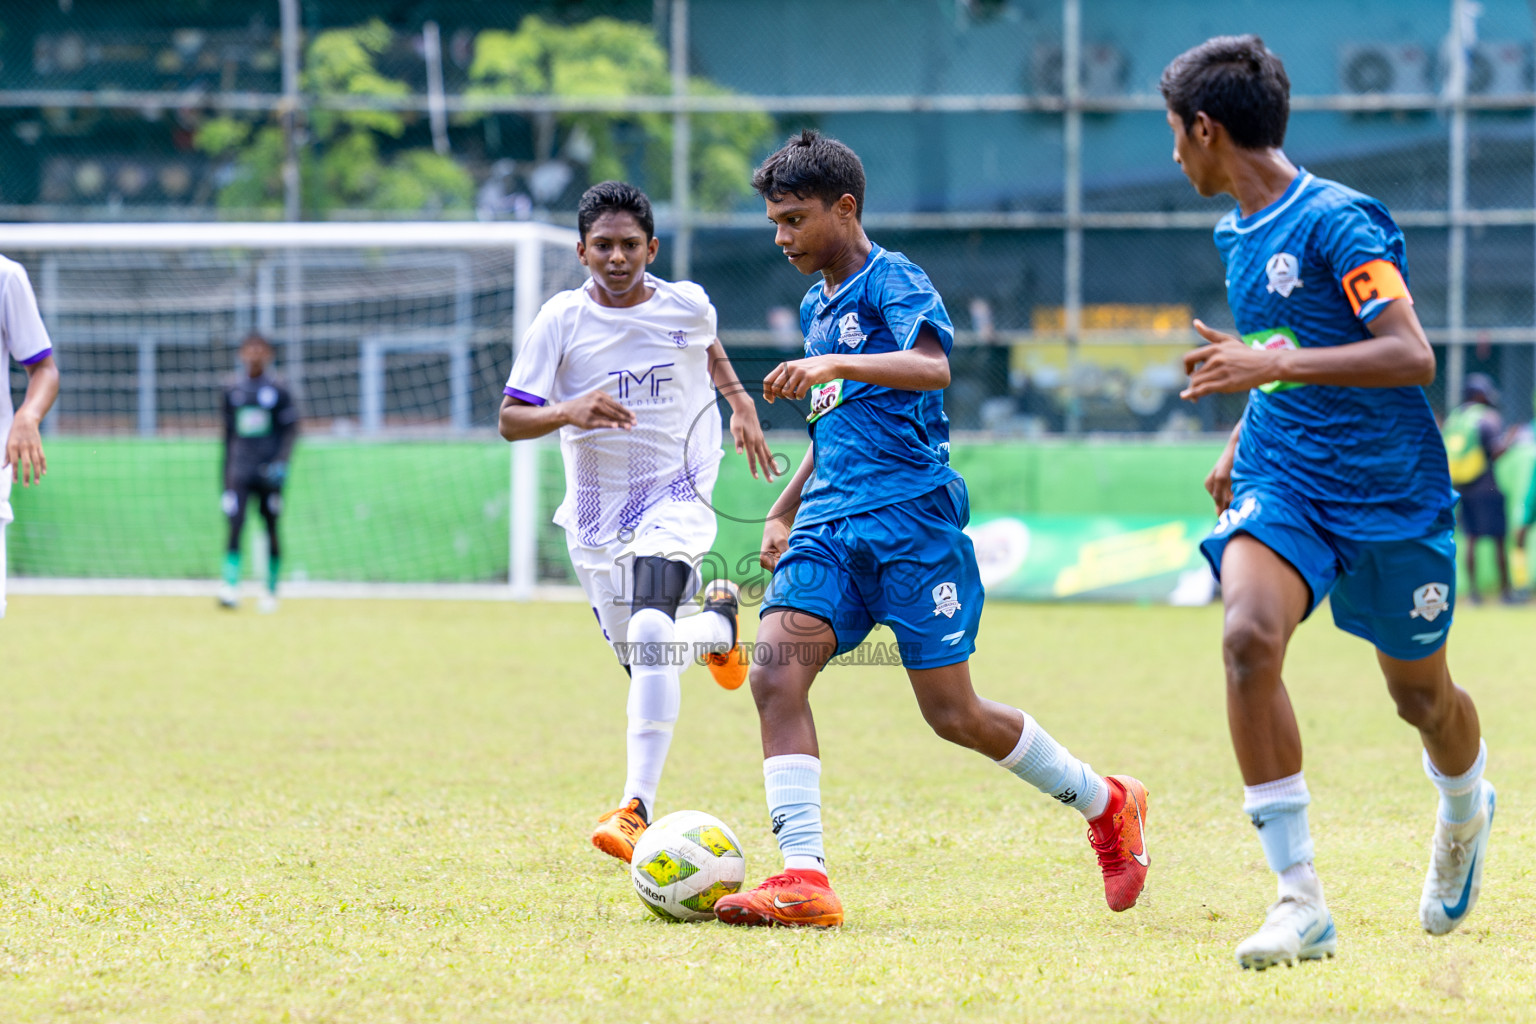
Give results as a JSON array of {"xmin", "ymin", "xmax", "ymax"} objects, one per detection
[{"xmin": 624, "ymin": 608, "xmax": 682, "ymax": 821}]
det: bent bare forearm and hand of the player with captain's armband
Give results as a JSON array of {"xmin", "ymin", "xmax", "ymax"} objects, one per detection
[{"xmin": 1180, "ymin": 299, "xmax": 1435, "ymax": 401}]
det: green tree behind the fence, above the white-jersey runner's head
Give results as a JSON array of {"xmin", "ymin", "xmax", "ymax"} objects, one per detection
[{"xmin": 467, "ymin": 14, "xmax": 777, "ymax": 209}]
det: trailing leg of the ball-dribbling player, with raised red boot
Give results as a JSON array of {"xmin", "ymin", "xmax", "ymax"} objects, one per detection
[{"xmin": 906, "ymin": 662, "xmax": 1150, "ymax": 910}]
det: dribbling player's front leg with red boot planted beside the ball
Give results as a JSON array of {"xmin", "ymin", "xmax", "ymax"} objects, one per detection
[{"xmin": 714, "ymin": 608, "xmax": 843, "ymax": 927}]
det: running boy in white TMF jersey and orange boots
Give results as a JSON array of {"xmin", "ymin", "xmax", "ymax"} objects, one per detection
[{"xmin": 501, "ymin": 181, "xmax": 774, "ymax": 861}]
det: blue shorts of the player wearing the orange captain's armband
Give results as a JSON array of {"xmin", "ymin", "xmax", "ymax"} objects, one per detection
[{"xmin": 1200, "ymin": 485, "xmax": 1456, "ymax": 662}]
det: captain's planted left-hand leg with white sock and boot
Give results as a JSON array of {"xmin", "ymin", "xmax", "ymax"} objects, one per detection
[{"xmin": 1221, "ymin": 534, "xmax": 1338, "ymax": 970}]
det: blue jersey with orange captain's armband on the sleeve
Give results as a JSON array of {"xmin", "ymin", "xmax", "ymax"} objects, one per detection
[{"xmin": 1215, "ymin": 170, "xmax": 1456, "ymax": 540}]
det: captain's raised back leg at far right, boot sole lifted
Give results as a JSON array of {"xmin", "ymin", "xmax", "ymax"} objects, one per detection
[{"xmin": 1376, "ymin": 646, "xmax": 1495, "ymax": 935}]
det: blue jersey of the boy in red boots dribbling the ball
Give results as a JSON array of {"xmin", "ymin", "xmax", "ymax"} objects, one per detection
[{"xmin": 794, "ymin": 246, "xmax": 960, "ymax": 527}]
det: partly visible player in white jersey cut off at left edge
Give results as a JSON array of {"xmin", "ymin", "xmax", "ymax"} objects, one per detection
[{"xmin": 0, "ymin": 256, "xmax": 58, "ymax": 619}]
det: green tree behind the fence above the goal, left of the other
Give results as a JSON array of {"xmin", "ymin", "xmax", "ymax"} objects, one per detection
[{"xmin": 194, "ymin": 18, "xmax": 475, "ymax": 216}]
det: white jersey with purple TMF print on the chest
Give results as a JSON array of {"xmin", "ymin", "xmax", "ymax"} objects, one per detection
[{"xmin": 505, "ymin": 275, "xmax": 722, "ymax": 547}]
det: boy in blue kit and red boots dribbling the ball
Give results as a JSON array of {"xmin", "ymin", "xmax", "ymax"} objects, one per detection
[{"xmin": 716, "ymin": 130, "xmax": 1147, "ymax": 927}]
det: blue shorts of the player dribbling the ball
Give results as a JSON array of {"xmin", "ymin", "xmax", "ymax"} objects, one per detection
[{"xmin": 762, "ymin": 479, "xmax": 983, "ymax": 669}]
